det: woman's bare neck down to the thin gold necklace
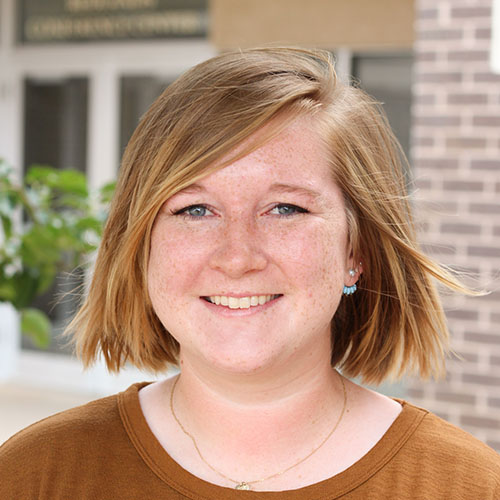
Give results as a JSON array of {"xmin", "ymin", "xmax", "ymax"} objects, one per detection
[{"xmin": 169, "ymin": 359, "xmax": 344, "ymax": 481}]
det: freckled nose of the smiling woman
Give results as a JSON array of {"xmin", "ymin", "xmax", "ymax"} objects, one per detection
[{"xmin": 209, "ymin": 217, "xmax": 267, "ymax": 278}]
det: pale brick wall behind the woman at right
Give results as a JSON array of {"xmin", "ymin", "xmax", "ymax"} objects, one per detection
[{"xmin": 409, "ymin": 0, "xmax": 500, "ymax": 451}]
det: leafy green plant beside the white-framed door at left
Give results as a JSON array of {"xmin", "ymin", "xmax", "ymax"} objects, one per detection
[{"xmin": 0, "ymin": 160, "xmax": 114, "ymax": 347}]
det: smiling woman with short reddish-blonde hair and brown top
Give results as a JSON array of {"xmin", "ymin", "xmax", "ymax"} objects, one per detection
[{"xmin": 0, "ymin": 48, "xmax": 500, "ymax": 500}]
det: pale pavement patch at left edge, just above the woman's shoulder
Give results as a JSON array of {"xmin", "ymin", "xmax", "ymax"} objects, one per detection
[{"xmin": 0, "ymin": 382, "xmax": 99, "ymax": 444}]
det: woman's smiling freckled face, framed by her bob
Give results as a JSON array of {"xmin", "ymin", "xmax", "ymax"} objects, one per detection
[{"xmin": 148, "ymin": 117, "xmax": 357, "ymax": 373}]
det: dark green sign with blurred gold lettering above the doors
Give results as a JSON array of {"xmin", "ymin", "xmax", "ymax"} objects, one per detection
[{"xmin": 18, "ymin": 0, "xmax": 208, "ymax": 44}]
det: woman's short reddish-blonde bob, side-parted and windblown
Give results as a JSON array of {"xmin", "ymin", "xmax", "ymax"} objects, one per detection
[{"xmin": 67, "ymin": 48, "xmax": 467, "ymax": 383}]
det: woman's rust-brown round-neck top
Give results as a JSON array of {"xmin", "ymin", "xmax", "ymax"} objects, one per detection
[{"xmin": 0, "ymin": 383, "xmax": 500, "ymax": 500}]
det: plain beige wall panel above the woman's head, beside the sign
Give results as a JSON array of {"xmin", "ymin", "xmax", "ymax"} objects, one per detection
[{"xmin": 210, "ymin": 0, "xmax": 414, "ymax": 51}]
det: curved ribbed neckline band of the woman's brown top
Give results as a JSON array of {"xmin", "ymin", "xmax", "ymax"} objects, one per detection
[{"xmin": 118, "ymin": 382, "xmax": 427, "ymax": 500}]
